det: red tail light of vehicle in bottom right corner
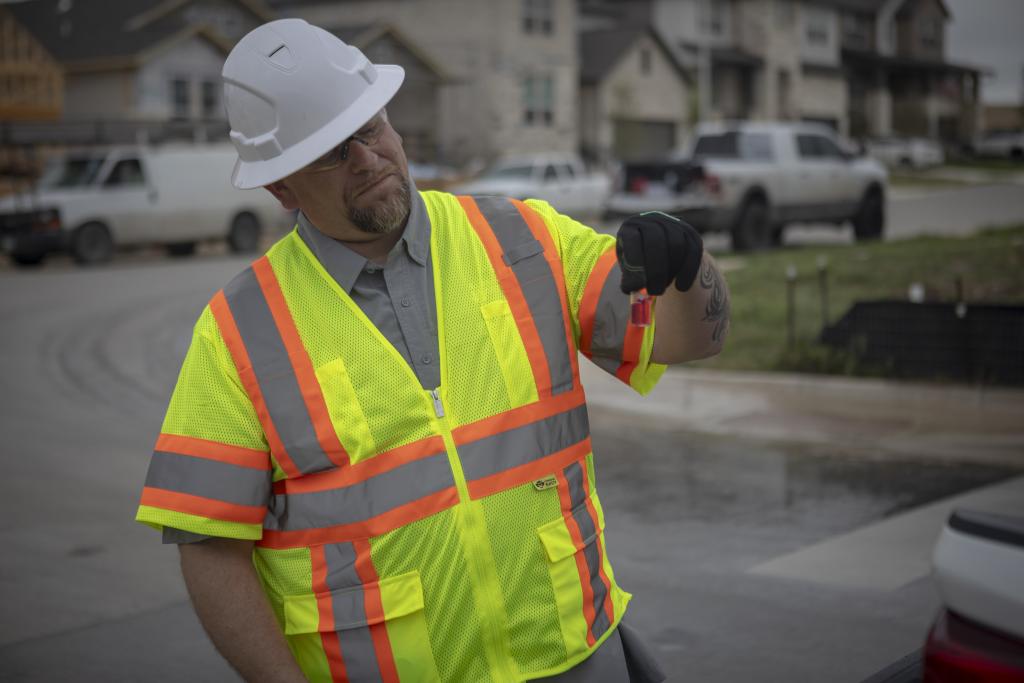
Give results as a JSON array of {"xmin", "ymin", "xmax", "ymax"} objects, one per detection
[{"xmin": 924, "ymin": 609, "xmax": 1024, "ymax": 683}]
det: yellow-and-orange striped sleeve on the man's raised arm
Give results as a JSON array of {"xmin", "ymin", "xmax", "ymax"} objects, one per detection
[{"xmin": 526, "ymin": 200, "xmax": 666, "ymax": 394}]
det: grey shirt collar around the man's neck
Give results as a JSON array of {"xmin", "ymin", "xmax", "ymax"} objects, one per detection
[{"xmin": 297, "ymin": 180, "xmax": 430, "ymax": 294}]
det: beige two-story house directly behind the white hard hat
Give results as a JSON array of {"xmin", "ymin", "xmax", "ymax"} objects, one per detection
[{"xmin": 271, "ymin": 0, "xmax": 580, "ymax": 165}]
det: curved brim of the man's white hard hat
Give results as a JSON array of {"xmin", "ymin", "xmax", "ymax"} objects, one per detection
[{"xmin": 231, "ymin": 65, "xmax": 406, "ymax": 189}]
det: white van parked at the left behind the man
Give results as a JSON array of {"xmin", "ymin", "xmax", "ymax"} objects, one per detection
[{"xmin": 0, "ymin": 144, "xmax": 292, "ymax": 265}]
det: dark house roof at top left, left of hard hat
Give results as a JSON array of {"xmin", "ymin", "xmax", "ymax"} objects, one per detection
[{"xmin": 7, "ymin": 0, "xmax": 271, "ymax": 65}]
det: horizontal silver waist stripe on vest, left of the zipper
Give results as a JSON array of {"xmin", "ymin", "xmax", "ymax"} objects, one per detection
[{"xmin": 263, "ymin": 452, "xmax": 455, "ymax": 531}]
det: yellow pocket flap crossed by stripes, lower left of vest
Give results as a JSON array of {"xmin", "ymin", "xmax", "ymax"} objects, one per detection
[{"xmin": 285, "ymin": 571, "xmax": 423, "ymax": 636}]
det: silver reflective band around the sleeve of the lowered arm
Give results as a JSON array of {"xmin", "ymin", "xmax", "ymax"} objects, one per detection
[{"xmin": 145, "ymin": 451, "xmax": 270, "ymax": 506}]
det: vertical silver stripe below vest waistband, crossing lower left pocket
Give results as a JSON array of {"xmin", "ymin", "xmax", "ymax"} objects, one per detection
[{"xmin": 324, "ymin": 543, "xmax": 383, "ymax": 681}]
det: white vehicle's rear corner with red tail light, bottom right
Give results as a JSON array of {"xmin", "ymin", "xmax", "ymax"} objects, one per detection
[{"xmin": 924, "ymin": 510, "xmax": 1024, "ymax": 683}]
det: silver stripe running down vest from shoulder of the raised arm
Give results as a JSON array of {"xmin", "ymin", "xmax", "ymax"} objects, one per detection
[{"xmin": 474, "ymin": 197, "xmax": 572, "ymax": 394}]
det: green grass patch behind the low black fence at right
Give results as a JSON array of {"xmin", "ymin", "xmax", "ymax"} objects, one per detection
[{"xmin": 692, "ymin": 223, "xmax": 1024, "ymax": 375}]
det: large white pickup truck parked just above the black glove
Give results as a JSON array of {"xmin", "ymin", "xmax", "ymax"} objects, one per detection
[{"xmin": 608, "ymin": 122, "xmax": 888, "ymax": 251}]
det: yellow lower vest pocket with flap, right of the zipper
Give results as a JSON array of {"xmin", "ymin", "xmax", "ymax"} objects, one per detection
[{"xmin": 537, "ymin": 499, "xmax": 617, "ymax": 659}]
